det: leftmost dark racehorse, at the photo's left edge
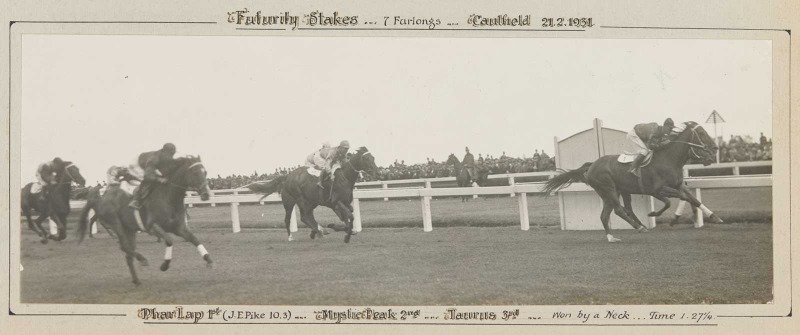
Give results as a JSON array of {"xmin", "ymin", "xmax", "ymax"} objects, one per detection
[{"xmin": 20, "ymin": 161, "xmax": 86, "ymax": 243}]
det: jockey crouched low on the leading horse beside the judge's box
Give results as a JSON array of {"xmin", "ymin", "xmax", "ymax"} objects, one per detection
[{"xmin": 624, "ymin": 118, "xmax": 675, "ymax": 177}]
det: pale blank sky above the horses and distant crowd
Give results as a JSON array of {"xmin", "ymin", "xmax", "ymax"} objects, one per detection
[{"xmin": 18, "ymin": 35, "xmax": 772, "ymax": 184}]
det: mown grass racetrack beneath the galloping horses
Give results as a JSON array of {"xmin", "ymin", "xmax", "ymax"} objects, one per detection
[{"xmin": 20, "ymin": 188, "xmax": 773, "ymax": 305}]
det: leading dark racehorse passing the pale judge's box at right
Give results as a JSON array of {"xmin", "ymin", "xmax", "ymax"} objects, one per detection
[{"xmin": 544, "ymin": 121, "xmax": 722, "ymax": 242}]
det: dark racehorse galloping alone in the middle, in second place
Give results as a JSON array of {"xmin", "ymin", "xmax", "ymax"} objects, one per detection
[{"xmin": 247, "ymin": 147, "xmax": 377, "ymax": 243}]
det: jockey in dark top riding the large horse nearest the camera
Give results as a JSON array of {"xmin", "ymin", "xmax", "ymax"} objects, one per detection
[{"xmin": 128, "ymin": 143, "xmax": 175, "ymax": 209}]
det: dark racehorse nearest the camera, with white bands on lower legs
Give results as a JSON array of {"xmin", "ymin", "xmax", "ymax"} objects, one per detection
[{"xmin": 78, "ymin": 157, "xmax": 212, "ymax": 285}]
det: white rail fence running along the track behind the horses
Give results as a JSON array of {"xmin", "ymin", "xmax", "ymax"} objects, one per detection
[{"xmin": 70, "ymin": 161, "xmax": 772, "ymax": 233}]
